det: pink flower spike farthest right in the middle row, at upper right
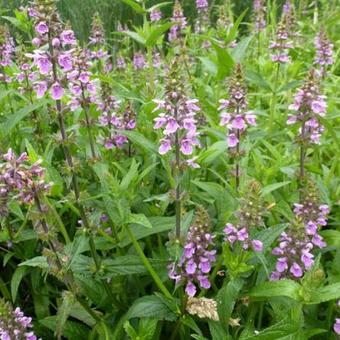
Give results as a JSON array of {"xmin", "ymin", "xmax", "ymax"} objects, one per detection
[{"xmin": 287, "ymin": 70, "xmax": 327, "ymax": 144}]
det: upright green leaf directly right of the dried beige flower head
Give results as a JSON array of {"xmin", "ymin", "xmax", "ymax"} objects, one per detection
[{"xmin": 216, "ymin": 278, "xmax": 244, "ymax": 330}]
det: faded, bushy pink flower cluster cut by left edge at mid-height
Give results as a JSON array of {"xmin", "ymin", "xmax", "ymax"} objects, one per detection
[{"xmin": 0, "ymin": 149, "xmax": 50, "ymax": 215}]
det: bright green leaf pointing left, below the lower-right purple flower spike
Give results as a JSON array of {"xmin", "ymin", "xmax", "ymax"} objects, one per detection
[{"xmin": 248, "ymin": 280, "xmax": 301, "ymax": 301}]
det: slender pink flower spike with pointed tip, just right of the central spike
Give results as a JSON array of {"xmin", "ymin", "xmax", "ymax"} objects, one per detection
[{"xmin": 219, "ymin": 64, "xmax": 256, "ymax": 148}]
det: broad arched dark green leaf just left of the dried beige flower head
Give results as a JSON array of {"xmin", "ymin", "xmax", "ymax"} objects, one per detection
[{"xmin": 127, "ymin": 295, "xmax": 177, "ymax": 321}]
